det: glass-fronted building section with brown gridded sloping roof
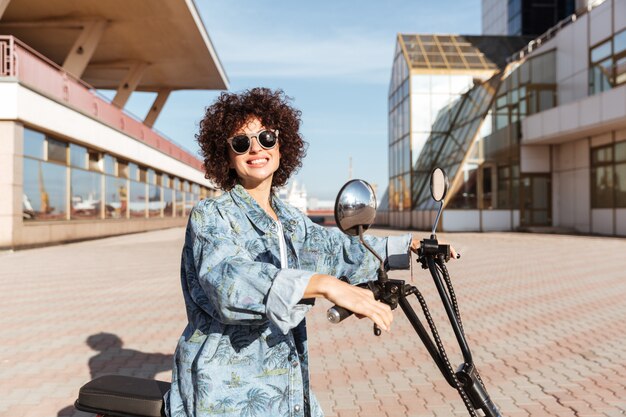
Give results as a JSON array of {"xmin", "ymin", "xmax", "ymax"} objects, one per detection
[{"xmin": 383, "ymin": 34, "xmax": 527, "ymax": 226}]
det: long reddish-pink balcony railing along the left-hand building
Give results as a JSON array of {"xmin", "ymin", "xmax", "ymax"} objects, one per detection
[{"xmin": 0, "ymin": 35, "xmax": 203, "ymax": 171}]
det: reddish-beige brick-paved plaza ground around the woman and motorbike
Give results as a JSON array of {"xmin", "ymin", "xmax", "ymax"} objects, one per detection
[{"xmin": 0, "ymin": 228, "xmax": 626, "ymax": 417}]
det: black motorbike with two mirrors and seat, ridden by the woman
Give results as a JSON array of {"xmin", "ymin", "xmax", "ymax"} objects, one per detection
[{"xmin": 74, "ymin": 168, "xmax": 501, "ymax": 417}]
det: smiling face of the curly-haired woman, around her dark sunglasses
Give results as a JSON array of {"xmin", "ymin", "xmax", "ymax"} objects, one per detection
[{"xmin": 228, "ymin": 117, "xmax": 280, "ymax": 189}]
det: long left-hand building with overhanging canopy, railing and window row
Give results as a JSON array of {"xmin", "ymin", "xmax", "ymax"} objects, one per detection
[{"xmin": 0, "ymin": 0, "xmax": 228, "ymax": 248}]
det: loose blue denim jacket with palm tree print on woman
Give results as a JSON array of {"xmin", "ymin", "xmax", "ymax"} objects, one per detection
[{"xmin": 165, "ymin": 185, "xmax": 410, "ymax": 417}]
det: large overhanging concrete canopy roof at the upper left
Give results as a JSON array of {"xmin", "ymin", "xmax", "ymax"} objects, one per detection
[{"xmin": 0, "ymin": 0, "xmax": 228, "ymax": 91}]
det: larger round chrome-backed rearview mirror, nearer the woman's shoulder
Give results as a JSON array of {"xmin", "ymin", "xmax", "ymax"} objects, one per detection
[{"xmin": 335, "ymin": 180, "xmax": 376, "ymax": 236}]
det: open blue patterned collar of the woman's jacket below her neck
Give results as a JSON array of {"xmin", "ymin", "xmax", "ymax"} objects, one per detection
[{"xmin": 229, "ymin": 184, "xmax": 297, "ymax": 233}]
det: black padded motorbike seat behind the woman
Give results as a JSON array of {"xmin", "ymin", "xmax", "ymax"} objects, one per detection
[{"xmin": 74, "ymin": 375, "xmax": 170, "ymax": 417}]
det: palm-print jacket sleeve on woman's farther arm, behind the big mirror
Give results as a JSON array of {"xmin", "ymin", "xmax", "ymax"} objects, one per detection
[{"xmin": 302, "ymin": 211, "xmax": 411, "ymax": 284}]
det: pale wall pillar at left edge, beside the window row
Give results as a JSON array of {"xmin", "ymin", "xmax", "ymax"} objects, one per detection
[{"xmin": 0, "ymin": 121, "xmax": 24, "ymax": 248}]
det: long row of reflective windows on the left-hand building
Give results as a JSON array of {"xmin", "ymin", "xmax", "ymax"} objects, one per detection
[{"xmin": 22, "ymin": 128, "xmax": 210, "ymax": 221}]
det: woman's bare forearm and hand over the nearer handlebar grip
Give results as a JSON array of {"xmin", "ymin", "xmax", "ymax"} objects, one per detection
[{"xmin": 304, "ymin": 274, "xmax": 393, "ymax": 331}]
